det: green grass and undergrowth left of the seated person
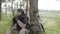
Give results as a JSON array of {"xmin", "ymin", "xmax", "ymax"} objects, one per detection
[{"xmin": 0, "ymin": 13, "xmax": 11, "ymax": 34}]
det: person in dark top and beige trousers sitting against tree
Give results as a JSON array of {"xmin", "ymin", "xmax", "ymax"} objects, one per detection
[{"xmin": 6, "ymin": 8, "xmax": 30, "ymax": 34}]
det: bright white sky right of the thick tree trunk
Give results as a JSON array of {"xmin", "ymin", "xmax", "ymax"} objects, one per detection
[{"xmin": 38, "ymin": 0, "xmax": 60, "ymax": 10}]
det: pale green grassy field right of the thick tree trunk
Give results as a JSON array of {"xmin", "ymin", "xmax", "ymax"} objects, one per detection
[{"xmin": 40, "ymin": 14, "xmax": 60, "ymax": 34}]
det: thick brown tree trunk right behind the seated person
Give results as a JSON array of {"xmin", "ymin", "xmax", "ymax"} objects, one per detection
[{"xmin": 30, "ymin": 0, "xmax": 38, "ymax": 22}]
